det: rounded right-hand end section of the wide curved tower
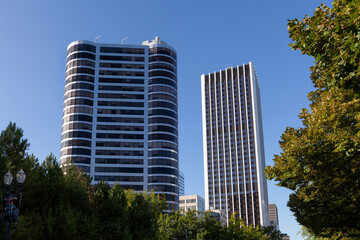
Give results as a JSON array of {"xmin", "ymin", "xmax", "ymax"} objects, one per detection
[{"xmin": 143, "ymin": 37, "xmax": 179, "ymax": 209}]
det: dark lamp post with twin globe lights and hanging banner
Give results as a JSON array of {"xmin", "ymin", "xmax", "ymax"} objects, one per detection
[{"xmin": 1, "ymin": 169, "xmax": 26, "ymax": 240}]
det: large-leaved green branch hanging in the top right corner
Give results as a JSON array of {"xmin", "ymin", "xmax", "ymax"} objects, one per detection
[{"xmin": 288, "ymin": 0, "xmax": 360, "ymax": 94}]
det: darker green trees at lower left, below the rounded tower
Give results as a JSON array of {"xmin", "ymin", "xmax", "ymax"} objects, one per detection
[{"xmin": 0, "ymin": 123, "xmax": 166, "ymax": 240}]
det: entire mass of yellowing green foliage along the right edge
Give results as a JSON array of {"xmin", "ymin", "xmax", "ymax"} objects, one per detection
[{"xmin": 266, "ymin": 0, "xmax": 360, "ymax": 238}]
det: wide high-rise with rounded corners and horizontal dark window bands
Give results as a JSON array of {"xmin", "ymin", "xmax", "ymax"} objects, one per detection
[{"xmin": 60, "ymin": 37, "xmax": 179, "ymax": 210}]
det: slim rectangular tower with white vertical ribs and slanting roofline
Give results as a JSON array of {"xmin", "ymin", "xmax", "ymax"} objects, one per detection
[{"xmin": 201, "ymin": 62, "xmax": 269, "ymax": 226}]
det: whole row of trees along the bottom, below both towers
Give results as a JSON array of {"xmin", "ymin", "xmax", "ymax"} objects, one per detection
[{"xmin": 0, "ymin": 123, "xmax": 278, "ymax": 240}]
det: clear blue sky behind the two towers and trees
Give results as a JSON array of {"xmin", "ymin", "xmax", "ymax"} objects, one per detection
[{"xmin": 0, "ymin": 0, "xmax": 330, "ymax": 239}]
